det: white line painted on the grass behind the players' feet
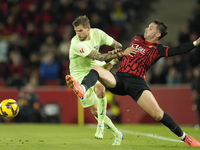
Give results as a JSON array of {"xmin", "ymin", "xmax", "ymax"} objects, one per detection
[{"xmin": 88, "ymin": 124, "xmax": 183, "ymax": 142}]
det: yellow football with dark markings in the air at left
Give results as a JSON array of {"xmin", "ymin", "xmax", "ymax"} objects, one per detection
[{"xmin": 0, "ymin": 99, "xmax": 19, "ymax": 119}]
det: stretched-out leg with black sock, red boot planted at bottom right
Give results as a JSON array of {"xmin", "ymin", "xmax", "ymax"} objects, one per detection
[{"xmin": 137, "ymin": 90, "xmax": 200, "ymax": 147}]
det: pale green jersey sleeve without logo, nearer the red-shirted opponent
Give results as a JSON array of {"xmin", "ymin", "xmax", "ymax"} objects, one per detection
[{"xmin": 96, "ymin": 29, "xmax": 114, "ymax": 46}]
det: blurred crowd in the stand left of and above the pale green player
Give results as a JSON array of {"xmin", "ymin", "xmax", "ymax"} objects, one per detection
[{"xmin": 0, "ymin": 0, "xmax": 150, "ymax": 88}]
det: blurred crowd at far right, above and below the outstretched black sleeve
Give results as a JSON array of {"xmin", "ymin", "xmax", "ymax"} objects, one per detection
[{"xmin": 148, "ymin": 0, "xmax": 200, "ymax": 86}]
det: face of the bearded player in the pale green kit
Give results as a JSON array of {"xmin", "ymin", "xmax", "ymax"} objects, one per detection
[{"xmin": 74, "ymin": 25, "xmax": 90, "ymax": 41}]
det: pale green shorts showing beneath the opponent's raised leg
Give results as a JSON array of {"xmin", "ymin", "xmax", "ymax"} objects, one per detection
[{"xmin": 80, "ymin": 86, "xmax": 98, "ymax": 108}]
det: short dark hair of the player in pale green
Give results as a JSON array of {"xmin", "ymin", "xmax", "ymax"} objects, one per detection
[{"xmin": 72, "ymin": 15, "xmax": 90, "ymax": 28}]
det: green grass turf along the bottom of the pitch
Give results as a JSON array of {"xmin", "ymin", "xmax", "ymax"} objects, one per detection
[{"xmin": 0, "ymin": 123, "xmax": 200, "ymax": 150}]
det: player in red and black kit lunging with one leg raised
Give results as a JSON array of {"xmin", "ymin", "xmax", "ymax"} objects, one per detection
[{"xmin": 66, "ymin": 20, "xmax": 200, "ymax": 147}]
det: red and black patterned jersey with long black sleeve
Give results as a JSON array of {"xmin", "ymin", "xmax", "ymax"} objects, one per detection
[{"xmin": 116, "ymin": 35, "xmax": 194, "ymax": 80}]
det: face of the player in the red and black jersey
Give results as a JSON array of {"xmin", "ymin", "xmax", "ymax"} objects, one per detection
[{"xmin": 144, "ymin": 23, "xmax": 161, "ymax": 41}]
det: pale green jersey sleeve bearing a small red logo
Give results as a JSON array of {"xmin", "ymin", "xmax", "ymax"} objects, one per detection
[{"xmin": 71, "ymin": 43, "xmax": 92, "ymax": 57}]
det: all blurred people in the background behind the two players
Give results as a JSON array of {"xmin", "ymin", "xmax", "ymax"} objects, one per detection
[{"xmin": 0, "ymin": 0, "xmax": 200, "ymax": 124}]
